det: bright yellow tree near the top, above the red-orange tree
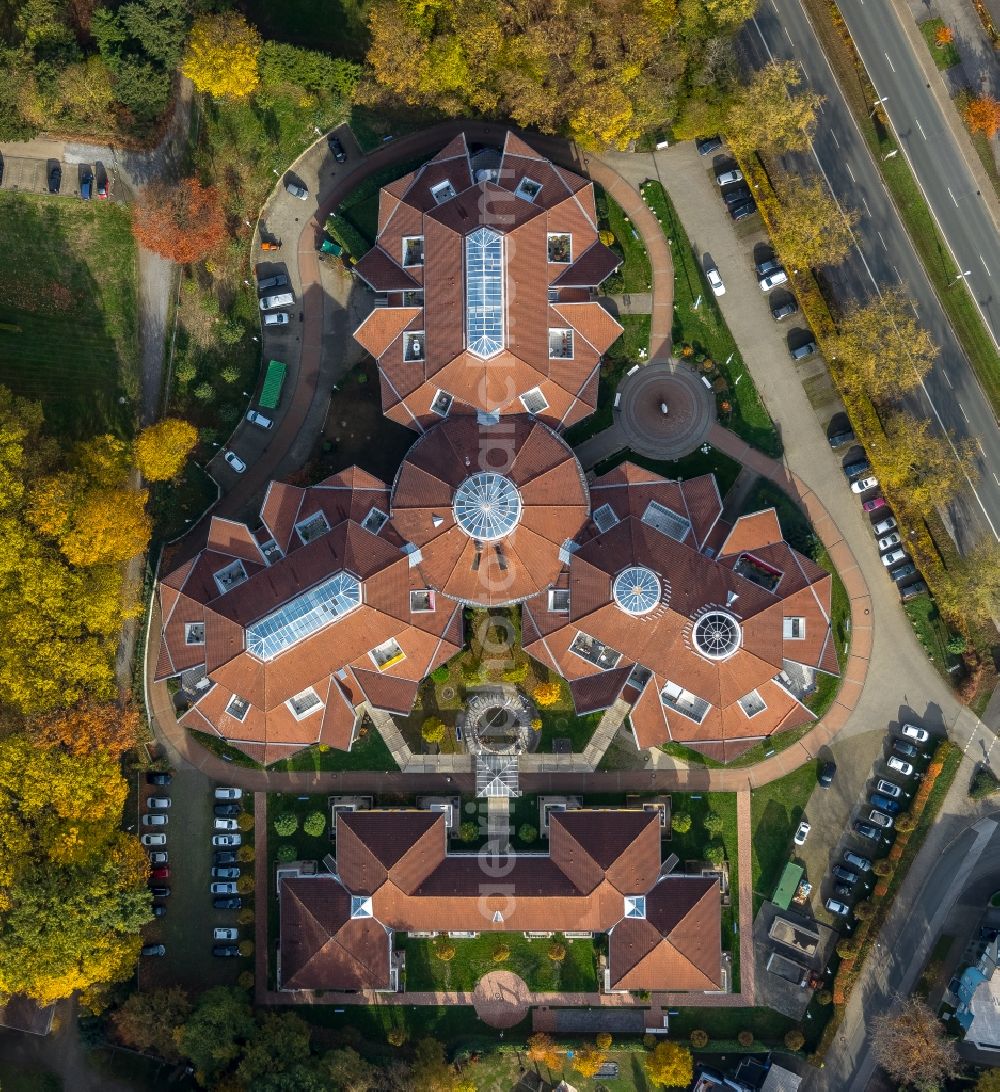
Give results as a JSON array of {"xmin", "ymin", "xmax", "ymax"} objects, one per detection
[{"xmin": 181, "ymin": 12, "xmax": 263, "ymax": 99}]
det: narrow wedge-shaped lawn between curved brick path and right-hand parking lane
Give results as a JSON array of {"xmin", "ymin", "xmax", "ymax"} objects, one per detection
[{"xmin": 642, "ymin": 182, "xmax": 783, "ymax": 456}]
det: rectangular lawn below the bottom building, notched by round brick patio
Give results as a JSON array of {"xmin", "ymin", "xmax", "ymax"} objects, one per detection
[{"xmin": 396, "ymin": 933, "xmax": 597, "ymax": 993}]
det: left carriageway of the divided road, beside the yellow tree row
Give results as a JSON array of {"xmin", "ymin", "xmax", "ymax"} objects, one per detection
[{"xmin": 741, "ymin": 0, "xmax": 1000, "ymax": 549}]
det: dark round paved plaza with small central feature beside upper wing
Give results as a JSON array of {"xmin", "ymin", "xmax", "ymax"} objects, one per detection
[{"xmin": 618, "ymin": 360, "xmax": 715, "ymax": 459}]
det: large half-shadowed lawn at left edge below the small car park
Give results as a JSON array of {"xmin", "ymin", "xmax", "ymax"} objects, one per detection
[{"xmin": 0, "ymin": 191, "xmax": 139, "ymax": 440}]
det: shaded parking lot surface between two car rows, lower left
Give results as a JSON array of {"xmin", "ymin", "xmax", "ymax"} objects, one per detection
[{"xmin": 138, "ymin": 768, "xmax": 253, "ymax": 992}]
